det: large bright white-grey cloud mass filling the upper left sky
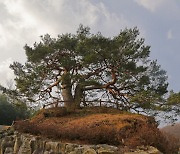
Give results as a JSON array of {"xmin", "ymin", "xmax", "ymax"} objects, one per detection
[{"xmin": 0, "ymin": 0, "xmax": 130, "ymax": 84}]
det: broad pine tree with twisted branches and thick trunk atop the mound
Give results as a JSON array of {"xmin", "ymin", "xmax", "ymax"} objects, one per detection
[{"xmin": 10, "ymin": 25, "xmax": 179, "ymax": 115}]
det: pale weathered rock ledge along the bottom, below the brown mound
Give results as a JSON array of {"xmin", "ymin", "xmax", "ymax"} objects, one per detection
[{"xmin": 0, "ymin": 132, "xmax": 166, "ymax": 154}]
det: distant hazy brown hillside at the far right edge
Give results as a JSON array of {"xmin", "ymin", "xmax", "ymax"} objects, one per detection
[{"xmin": 161, "ymin": 123, "xmax": 180, "ymax": 140}]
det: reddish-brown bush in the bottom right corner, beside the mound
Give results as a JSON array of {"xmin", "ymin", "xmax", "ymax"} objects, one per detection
[{"xmin": 126, "ymin": 125, "xmax": 179, "ymax": 154}]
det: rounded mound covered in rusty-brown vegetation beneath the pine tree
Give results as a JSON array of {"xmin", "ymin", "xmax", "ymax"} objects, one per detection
[{"xmin": 15, "ymin": 107, "xmax": 177, "ymax": 152}]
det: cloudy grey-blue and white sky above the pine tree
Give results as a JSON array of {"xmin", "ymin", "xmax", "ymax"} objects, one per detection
[{"xmin": 0, "ymin": 0, "xmax": 180, "ymax": 91}]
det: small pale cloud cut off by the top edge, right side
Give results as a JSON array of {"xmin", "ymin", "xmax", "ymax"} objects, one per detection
[{"xmin": 134, "ymin": 0, "xmax": 165, "ymax": 12}]
